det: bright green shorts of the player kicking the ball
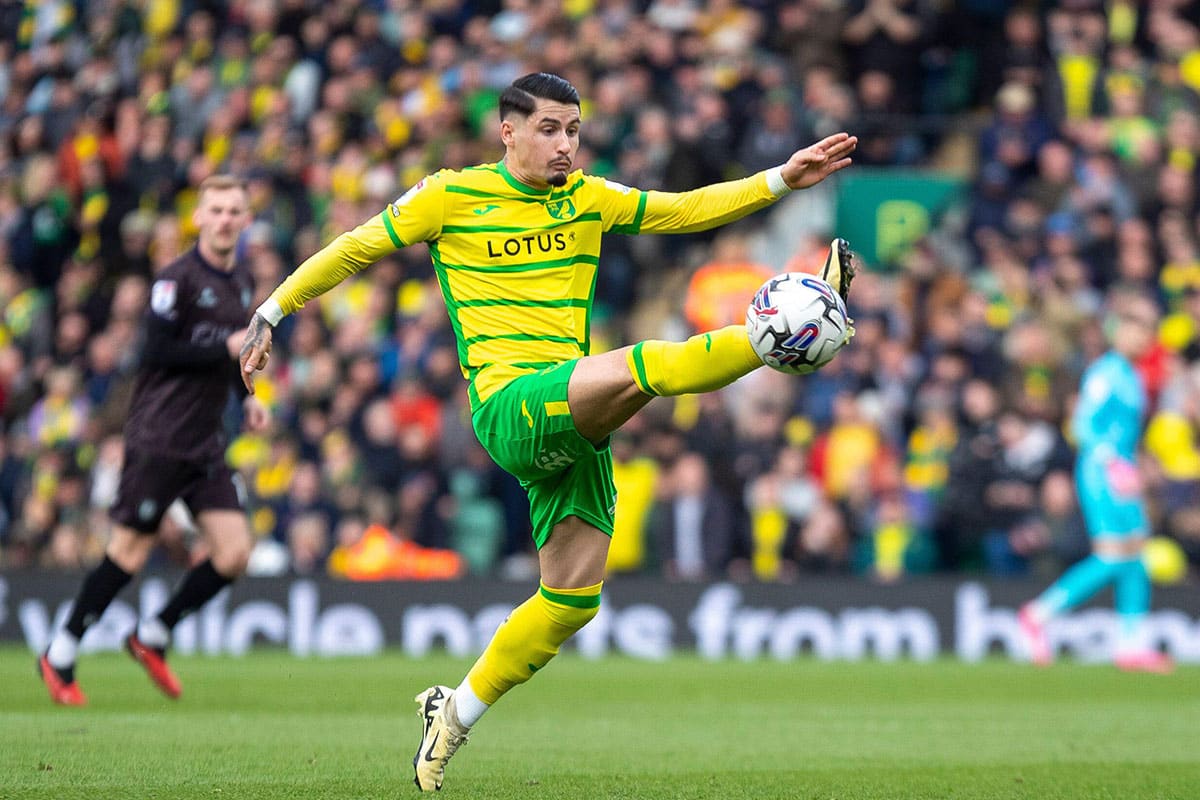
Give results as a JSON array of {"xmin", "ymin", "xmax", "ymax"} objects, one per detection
[{"xmin": 472, "ymin": 361, "xmax": 617, "ymax": 549}]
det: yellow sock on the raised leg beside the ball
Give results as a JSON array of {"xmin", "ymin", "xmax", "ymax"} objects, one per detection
[{"xmin": 625, "ymin": 325, "xmax": 762, "ymax": 397}]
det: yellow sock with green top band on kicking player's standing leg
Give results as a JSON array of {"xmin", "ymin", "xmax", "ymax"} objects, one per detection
[{"xmin": 467, "ymin": 582, "xmax": 604, "ymax": 705}]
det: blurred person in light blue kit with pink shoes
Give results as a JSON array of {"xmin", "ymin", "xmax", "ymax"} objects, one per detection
[{"xmin": 1019, "ymin": 291, "xmax": 1172, "ymax": 673}]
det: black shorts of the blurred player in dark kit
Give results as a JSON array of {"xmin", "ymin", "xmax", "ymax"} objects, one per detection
[{"xmin": 108, "ymin": 449, "xmax": 244, "ymax": 534}]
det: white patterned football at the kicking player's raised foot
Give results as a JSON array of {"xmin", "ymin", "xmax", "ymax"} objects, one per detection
[{"xmin": 746, "ymin": 272, "xmax": 853, "ymax": 375}]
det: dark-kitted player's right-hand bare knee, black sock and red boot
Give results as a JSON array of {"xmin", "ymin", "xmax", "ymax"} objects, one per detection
[{"xmin": 125, "ymin": 510, "xmax": 253, "ymax": 699}]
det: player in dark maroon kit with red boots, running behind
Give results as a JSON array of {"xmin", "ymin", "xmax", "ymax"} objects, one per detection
[{"xmin": 37, "ymin": 175, "xmax": 269, "ymax": 705}]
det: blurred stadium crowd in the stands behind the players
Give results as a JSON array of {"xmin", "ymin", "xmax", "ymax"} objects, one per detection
[{"xmin": 0, "ymin": 0, "xmax": 1200, "ymax": 581}]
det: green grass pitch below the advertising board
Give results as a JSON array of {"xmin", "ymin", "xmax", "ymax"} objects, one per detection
[{"xmin": 0, "ymin": 646, "xmax": 1200, "ymax": 800}]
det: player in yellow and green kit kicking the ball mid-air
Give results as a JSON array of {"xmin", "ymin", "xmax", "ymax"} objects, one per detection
[{"xmin": 241, "ymin": 73, "xmax": 858, "ymax": 790}]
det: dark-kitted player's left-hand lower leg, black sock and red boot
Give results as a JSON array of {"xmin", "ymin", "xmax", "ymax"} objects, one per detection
[{"xmin": 37, "ymin": 525, "xmax": 155, "ymax": 705}]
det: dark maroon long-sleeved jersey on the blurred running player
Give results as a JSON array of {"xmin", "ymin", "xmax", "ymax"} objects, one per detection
[{"xmin": 125, "ymin": 247, "xmax": 254, "ymax": 461}]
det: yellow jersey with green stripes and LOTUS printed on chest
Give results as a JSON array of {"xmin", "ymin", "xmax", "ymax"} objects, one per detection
[{"xmin": 271, "ymin": 162, "xmax": 778, "ymax": 409}]
